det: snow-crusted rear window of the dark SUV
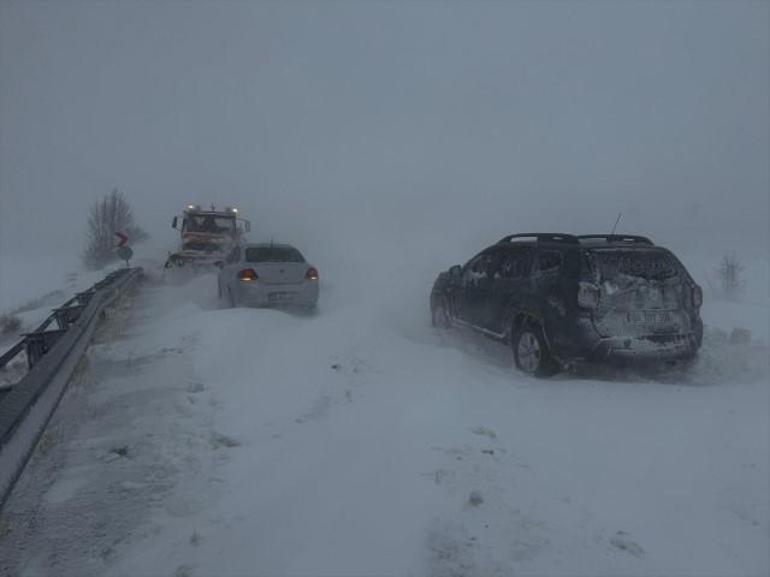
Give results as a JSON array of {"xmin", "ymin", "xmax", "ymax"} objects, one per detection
[{"xmin": 589, "ymin": 250, "xmax": 679, "ymax": 280}]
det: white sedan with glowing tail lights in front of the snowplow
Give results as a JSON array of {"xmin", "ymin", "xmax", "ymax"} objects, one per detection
[{"xmin": 217, "ymin": 243, "xmax": 319, "ymax": 310}]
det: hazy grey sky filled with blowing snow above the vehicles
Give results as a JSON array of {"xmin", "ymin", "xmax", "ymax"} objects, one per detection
[{"xmin": 0, "ymin": 0, "xmax": 770, "ymax": 264}]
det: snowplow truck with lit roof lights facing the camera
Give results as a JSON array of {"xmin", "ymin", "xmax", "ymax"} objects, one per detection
[{"xmin": 165, "ymin": 204, "xmax": 251, "ymax": 268}]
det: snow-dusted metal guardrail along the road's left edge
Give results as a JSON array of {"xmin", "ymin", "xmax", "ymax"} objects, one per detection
[{"xmin": 0, "ymin": 268, "xmax": 142, "ymax": 510}]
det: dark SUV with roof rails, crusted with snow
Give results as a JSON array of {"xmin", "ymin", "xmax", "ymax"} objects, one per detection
[{"xmin": 430, "ymin": 233, "xmax": 703, "ymax": 375}]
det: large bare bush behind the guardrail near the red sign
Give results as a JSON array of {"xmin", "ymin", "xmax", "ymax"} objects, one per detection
[{"xmin": 83, "ymin": 188, "xmax": 148, "ymax": 269}]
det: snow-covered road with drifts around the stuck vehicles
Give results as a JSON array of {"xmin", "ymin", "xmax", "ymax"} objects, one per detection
[{"xmin": 0, "ymin": 262, "xmax": 770, "ymax": 577}]
